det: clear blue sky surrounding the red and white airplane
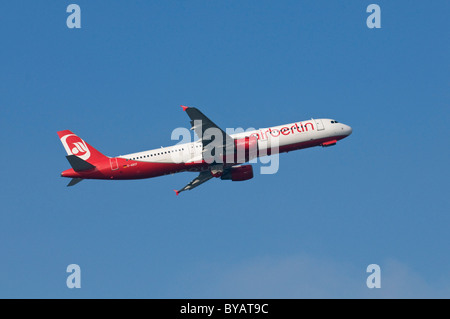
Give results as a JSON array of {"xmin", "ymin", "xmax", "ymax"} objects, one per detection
[{"xmin": 0, "ymin": 0, "xmax": 450, "ymax": 298}]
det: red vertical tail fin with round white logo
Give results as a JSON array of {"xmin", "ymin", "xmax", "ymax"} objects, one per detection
[{"xmin": 58, "ymin": 130, "xmax": 108, "ymax": 164}]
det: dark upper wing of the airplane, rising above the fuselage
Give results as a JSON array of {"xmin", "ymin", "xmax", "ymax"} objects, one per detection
[{"xmin": 181, "ymin": 105, "xmax": 234, "ymax": 151}]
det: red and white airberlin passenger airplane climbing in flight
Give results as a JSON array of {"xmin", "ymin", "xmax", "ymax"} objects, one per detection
[{"xmin": 58, "ymin": 105, "xmax": 352, "ymax": 195}]
